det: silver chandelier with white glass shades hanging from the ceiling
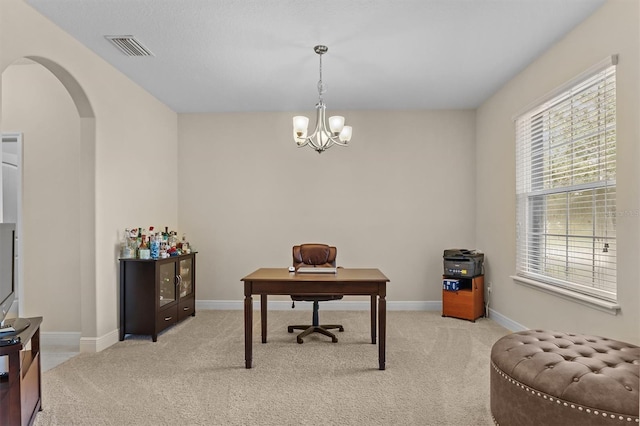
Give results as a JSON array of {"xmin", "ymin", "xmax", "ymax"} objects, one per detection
[{"xmin": 293, "ymin": 45, "xmax": 351, "ymax": 154}]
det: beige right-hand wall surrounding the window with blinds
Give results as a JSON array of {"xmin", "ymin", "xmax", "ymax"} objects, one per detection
[{"xmin": 476, "ymin": 0, "xmax": 640, "ymax": 343}]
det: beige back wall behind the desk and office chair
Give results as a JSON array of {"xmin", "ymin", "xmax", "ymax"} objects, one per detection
[{"xmin": 178, "ymin": 110, "xmax": 475, "ymax": 302}]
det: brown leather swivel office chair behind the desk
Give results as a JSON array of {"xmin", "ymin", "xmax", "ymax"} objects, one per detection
[{"xmin": 287, "ymin": 244, "xmax": 344, "ymax": 343}]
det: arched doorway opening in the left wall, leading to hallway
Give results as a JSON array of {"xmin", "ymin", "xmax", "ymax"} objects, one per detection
[{"xmin": 0, "ymin": 56, "xmax": 97, "ymax": 350}]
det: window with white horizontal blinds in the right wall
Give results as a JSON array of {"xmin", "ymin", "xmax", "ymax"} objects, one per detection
[{"xmin": 516, "ymin": 56, "xmax": 617, "ymax": 302}]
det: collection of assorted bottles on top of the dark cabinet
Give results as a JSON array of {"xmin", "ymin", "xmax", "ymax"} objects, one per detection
[{"xmin": 120, "ymin": 226, "xmax": 191, "ymax": 259}]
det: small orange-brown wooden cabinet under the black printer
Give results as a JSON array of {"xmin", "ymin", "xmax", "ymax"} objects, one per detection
[{"xmin": 442, "ymin": 275, "xmax": 484, "ymax": 322}]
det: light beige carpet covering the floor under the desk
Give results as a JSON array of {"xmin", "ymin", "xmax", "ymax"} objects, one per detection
[{"xmin": 35, "ymin": 310, "xmax": 509, "ymax": 426}]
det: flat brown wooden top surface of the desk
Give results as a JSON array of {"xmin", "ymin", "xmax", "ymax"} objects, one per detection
[{"xmin": 240, "ymin": 268, "xmax": 389, "ymax": 282}]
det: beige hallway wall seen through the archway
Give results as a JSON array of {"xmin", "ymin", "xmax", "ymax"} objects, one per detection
[{"xmin": 2, "ymin": 60, "xmax": 81, "ymax": 331}]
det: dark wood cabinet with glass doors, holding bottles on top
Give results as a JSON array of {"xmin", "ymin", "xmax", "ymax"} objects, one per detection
[{"xmin": 120, "ymin": 253, "xmax": 196, "ymax": 342}]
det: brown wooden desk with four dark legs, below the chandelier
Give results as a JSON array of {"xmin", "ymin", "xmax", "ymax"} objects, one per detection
[{"xmin": 241, "ymin": 268, "xmax": 389, "ymax": 370}]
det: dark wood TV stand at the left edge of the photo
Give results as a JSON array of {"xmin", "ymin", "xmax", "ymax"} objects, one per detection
[{"xmin": 0, "ymin": 317, "xmax": 42, "ymax": 426}]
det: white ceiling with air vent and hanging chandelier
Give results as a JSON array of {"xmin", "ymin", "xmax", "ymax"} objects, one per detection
[{"xmin": 25, "ymin": 0, "xmax": 605, "ymax": 112}]
